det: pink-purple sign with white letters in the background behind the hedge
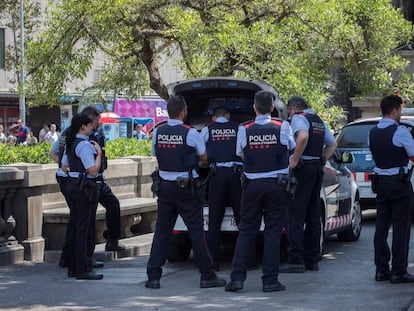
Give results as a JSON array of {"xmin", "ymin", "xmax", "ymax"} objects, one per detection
[{"xmin": 114, "ymin": 99, "xmax": 168, "ymax": 131}]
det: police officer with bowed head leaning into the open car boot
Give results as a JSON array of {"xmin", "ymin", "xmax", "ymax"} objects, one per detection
[{"xmin": 201, "ymin": 106, "xmax": 243, "ymax": 271}]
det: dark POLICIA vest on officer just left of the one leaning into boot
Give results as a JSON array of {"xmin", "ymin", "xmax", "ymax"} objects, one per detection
[{"xmin": 155, "ymin": 124, "xmax": 197, "ymax": 172}]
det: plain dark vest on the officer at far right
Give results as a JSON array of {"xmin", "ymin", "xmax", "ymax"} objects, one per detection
[{"xmin": 369, "ymin": 124, "xmax": 408, "ymax": 169}]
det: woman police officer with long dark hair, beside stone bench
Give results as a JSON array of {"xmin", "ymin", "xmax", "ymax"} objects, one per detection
[{"xmin": 62, "ymin": 114, "xmax": 103, "ymax": 280}]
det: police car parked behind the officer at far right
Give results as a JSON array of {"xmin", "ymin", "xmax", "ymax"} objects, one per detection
[{"xmin": 336, "ymin": 116, "xmax": 414, "ymax": 209}]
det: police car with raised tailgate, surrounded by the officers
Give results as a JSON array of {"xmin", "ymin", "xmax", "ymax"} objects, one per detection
[{"xmin": 163, "ymin": 77, "xmax": 361, "ymax": 261}]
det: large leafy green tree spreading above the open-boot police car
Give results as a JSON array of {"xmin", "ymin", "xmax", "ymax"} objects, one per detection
[{"xmin": 27, "ymin": 0, "xmax": 412, "ymax": 124}]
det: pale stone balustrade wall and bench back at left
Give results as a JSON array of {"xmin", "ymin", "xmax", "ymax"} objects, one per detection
[{"xmin": 0, "ymin": 156, "xmax": 157, "ymax": 265}]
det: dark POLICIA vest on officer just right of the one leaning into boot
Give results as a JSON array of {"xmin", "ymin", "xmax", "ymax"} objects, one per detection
[{"xmin": 243, "ymin": 118, "xmax": 289, "ymax": 173}]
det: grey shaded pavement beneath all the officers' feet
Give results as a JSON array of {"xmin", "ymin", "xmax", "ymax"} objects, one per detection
[{"xmin": 0, "ymin": 217, "xmax": 414, "ymax": 311}]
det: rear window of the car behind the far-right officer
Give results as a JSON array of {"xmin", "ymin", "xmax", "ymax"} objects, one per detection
[{"xmin": 337, "ymin": 123, "xmax": 375, "ymax": 148}]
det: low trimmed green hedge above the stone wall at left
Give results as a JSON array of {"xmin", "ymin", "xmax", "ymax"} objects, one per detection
[{"xmin": 0, "ymin": 138, "xmax": 151, "ymax": 165}]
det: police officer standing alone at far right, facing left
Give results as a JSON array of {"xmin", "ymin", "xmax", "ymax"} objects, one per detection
[{"xmin": 369, "ymin": 95, "xmax": 414, "ymax": 283}]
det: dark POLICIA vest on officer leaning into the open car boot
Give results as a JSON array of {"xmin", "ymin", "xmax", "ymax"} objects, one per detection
[{"xmin": 206, "ymin": 121, "xmax": 242, "ymax": 163}]
